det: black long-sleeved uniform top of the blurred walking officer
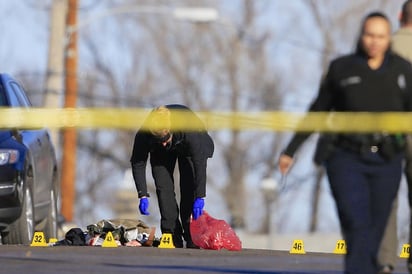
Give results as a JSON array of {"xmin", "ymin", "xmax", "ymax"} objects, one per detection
[{"xmin": 284, "ymin": 52, "xmax": 412, "ymax": 156}]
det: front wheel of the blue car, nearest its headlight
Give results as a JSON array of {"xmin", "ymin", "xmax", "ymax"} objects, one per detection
[{"xmin": 1, "ymin": 182, "xmax": 34, "ymax": 244}]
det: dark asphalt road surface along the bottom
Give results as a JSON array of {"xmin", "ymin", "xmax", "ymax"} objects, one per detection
[{"xmin": 0, "ymin": 245, "xmax": 407, "ymax": 274}]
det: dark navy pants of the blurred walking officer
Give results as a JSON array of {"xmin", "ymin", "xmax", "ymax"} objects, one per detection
[{"xmin": 326, "ymin": 150, "xmax": 403, "ymax": 274}]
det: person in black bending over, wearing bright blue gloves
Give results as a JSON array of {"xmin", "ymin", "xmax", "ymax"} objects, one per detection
[{"xmin": 131, "ymin": 105, "xmax": 214, "ymax": 248}]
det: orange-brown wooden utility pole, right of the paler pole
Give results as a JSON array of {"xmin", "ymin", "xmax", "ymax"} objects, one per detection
[{"xmin": 61, "ymin": 0, "xmax": 78, "ymax": 222}]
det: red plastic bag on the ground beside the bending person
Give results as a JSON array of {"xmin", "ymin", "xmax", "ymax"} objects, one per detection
[{"xmin": 190, "ymin": 211, "xmax": 242, "ymax": 251}]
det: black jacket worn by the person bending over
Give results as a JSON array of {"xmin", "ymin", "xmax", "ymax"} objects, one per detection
[{"xmin": 130, "ymin": 105, "xmax": 214, "ymax": 197}]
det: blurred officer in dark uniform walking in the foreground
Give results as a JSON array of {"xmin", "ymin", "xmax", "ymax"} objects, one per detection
[{"xmin": 279, "ymin": 12, "xmax": 412, "ymax": 274}]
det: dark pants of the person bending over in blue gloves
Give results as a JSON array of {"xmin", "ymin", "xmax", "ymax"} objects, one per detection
[{"xmin": 150, "ymin": 151, "xmax": 195, "ymax": 247}]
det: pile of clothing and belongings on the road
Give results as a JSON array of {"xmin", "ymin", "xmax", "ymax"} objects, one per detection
[{"xmin": 54, "ymin": 219, "xmax": 160, "ymax": 247}]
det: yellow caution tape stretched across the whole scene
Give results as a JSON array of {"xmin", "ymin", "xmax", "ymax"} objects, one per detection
[{"xmin": 0, "ymin": 108, "xmax": 412, "ymax": 133}]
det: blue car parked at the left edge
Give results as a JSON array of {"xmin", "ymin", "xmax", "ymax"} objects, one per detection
[{"xmin": 0, "ymin": 74, "xmax": 59, "ymax": 244}]
